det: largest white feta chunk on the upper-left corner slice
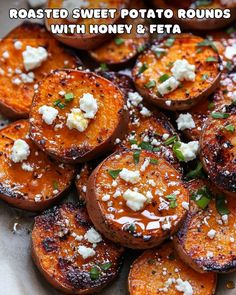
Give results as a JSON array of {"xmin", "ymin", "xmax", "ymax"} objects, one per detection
[{"xmin": 22, "ymin": 46, "xmax": 48, "ymax": 71}]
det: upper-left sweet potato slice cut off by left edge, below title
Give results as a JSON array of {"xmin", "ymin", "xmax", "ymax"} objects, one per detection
[{"xmin": 0, "ymin": 23, "xmax": 79, "ymax": 119}]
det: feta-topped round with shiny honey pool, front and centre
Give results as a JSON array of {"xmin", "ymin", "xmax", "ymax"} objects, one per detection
[{"xmin": 86, "ymin": 150, "xmax": 189, "ymax": 249}]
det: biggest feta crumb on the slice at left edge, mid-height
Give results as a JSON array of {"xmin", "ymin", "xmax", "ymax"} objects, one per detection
[{"xmin": 10, "ymin": 139, "xmax": 30, "ymax": 163}]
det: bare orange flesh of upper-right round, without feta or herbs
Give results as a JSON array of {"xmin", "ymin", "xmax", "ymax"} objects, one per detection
[{"xmin": 133, "ymin": 34, "xmax": 220, "ymax": 110}]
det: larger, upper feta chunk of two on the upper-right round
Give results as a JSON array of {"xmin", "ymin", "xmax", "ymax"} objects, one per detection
[{"xmin": 171, "ymin": 59, "xmax": 196, "ymax": 81}]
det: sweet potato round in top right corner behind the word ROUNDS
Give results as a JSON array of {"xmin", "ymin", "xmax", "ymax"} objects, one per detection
[{"xmin": 152, "ymin": 0, "xmax": 236, "ymax": 31}]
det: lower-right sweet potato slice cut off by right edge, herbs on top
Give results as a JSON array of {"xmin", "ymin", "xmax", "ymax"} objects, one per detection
[{"xmin": 174, "ymin": 180, "xmax": 236, "ymax": 273}]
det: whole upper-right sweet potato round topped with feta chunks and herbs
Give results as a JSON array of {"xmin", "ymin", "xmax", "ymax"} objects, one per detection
[{"xmin": 133, "ymin": 34, "xmax": 220, "ymax": 110}]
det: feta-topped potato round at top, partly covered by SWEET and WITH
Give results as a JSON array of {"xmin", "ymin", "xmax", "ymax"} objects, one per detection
[{"xmin": 46, "ymin": 0, "xmax": 129, "ymax": 50}]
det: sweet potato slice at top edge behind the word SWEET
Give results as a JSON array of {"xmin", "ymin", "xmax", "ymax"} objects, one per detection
[{"xmin": 46, "ymin": 0, "xmax": 129, "ymax": 50}]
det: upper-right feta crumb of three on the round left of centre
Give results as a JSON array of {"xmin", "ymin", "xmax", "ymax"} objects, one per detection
[{"xmin": 80, "ymin": 93, "xmax": 98, "ymax": 119}]
